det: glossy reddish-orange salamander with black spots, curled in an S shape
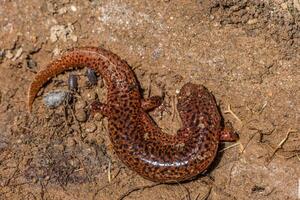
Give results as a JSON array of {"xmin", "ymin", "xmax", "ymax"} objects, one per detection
[{"xmin": 28, "ymin": 47, "xmax": 238, "ymax": 183}]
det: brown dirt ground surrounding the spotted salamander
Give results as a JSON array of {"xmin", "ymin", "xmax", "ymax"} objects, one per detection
[{"xmin": 0, "ymin": 0, "xmax": 300, "ymax": 200}]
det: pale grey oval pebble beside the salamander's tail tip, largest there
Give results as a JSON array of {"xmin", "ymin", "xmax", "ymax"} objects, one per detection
[{"xmin": 43, "ymin": 91, "xmax": 68, "ymax": 108}]
